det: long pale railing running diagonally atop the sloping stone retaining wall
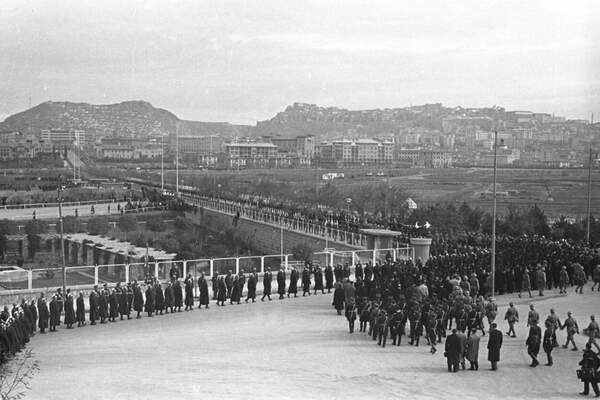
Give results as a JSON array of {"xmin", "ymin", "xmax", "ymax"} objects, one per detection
[{"xmin": 181, "ymin": 194, "xmax": 367, "ymax": 247}]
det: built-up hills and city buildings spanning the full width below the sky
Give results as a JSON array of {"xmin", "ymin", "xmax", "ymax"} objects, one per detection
[{"xmin": 0, "ymin": 101, "xmax": 600, "ymax": 168}]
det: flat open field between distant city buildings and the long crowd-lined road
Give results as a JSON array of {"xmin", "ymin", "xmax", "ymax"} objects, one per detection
[{"xmin": 156, "ymin": 168, "xmax": 600, "ymax": 218}]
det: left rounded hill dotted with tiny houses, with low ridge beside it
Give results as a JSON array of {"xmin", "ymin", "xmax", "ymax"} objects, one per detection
[{"xmin": 0, "ymin": 101, "xmax": 252, "ymax": 137}]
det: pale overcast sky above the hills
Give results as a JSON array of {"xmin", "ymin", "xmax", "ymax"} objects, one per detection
[{"xmin": 0, "ymin": 0, "xmax": 600, "ymax": 124}]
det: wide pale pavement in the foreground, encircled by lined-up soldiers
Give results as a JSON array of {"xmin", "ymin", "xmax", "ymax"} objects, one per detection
[{"xmin": 18, "ymin": 285, "xmax": 600, "ymax": 400}]
